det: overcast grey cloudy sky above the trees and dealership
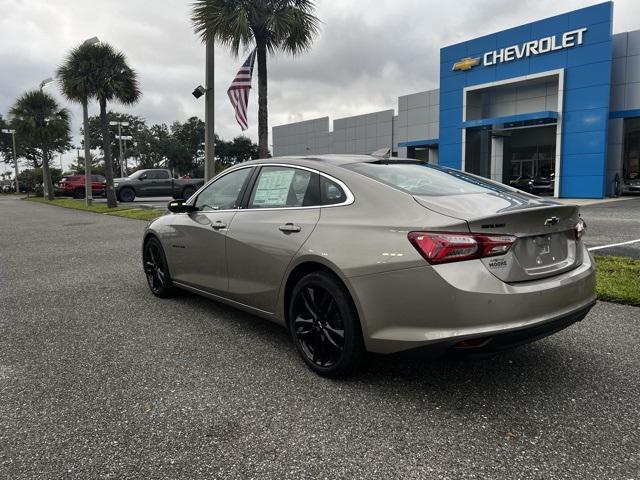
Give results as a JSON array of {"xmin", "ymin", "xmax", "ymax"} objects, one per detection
[{"xmin": 0, "ymin": 0, "xmax": 640, "ymax": 170}]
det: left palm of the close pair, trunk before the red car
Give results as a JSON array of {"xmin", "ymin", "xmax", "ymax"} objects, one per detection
[{"xmin": 57, "ymin": 42, "xmax": 99, "ymax": 206}]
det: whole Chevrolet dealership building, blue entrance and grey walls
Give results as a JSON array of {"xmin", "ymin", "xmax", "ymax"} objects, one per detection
[{"xmin": 272, "ymin": 2, "xmax": 640, "ymax": 198}]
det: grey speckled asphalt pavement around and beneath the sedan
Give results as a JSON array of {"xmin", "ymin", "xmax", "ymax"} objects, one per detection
[{"xmin": 0, "ymin": 197, "xmax": 640, "ymax": 480}]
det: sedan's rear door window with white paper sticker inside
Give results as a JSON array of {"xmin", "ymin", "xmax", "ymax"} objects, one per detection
[{"xmin": 249, "ymin": 167, "xmax": 320, "ymax": 208}]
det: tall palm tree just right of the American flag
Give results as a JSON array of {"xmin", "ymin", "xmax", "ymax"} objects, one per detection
[{"xmin": 191, "ymin": 0, "xmax": 320, "ymax": 158}]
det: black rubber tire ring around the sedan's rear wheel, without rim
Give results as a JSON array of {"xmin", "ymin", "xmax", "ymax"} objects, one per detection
[{"xmin": 287, "ymin": 272, "xmax": 364, "ymax": 377}]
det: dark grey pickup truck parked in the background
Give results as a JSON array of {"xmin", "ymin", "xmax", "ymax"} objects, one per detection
[{"xmin": 113, "ymin": 168, "xmax": 204, "ymax": 202}]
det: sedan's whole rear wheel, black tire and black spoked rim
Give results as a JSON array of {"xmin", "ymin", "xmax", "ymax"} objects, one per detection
[{"xmin": 287, "ymin": 271, "xmax": 365, "ymax": 378}]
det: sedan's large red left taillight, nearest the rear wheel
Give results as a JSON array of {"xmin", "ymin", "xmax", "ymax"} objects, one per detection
[{"xmin": 408, "ymin": 232, "xmax": 516, "ymax": 265}]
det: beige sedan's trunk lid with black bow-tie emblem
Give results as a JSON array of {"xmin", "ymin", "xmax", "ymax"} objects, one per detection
[{"xmin": 414, "ymin": 191, "xmax": 582, "ymax": 282}]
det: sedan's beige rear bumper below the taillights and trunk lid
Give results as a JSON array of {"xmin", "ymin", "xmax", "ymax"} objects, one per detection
[{"xmin": 349, "ymin": 247, "xmax": 595, "ymax": 353}]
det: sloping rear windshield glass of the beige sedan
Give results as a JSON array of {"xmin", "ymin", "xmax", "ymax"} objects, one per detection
[{"xmin": 347, "ymin": 162, "xmax": 512, "ymax": 195}]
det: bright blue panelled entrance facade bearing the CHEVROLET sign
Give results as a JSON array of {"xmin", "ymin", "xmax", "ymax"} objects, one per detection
[{"xmin": 439, "ymin": 2, "xmax": 613, "ymax": 198}]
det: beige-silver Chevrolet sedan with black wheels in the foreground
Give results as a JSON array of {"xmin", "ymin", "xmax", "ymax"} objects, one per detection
[{"xmin": 142, "ymin": 155, "xmax": 595, "ymax": 376}]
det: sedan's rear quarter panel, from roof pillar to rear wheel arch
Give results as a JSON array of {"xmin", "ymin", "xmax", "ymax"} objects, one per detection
[{"xmin": 277, "ymin": 172, "xmax": 468, "ymax": 335}]
